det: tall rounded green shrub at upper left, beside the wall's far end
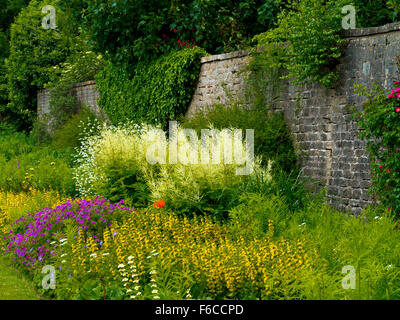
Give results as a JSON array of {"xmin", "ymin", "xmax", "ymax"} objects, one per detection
[{"xmin": 5, "ymin": 0, "xmax": 77, "ymax": 131}]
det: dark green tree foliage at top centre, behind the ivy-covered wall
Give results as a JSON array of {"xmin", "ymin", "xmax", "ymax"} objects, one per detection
[{"xmin": 63, "ymin": 0, "xmax": 285, "ymax": 65}]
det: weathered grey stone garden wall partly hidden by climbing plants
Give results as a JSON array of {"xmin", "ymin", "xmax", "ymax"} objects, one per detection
[{"xmin": 38, "ymin": 24, "xmax": 400, "ymax": 212}]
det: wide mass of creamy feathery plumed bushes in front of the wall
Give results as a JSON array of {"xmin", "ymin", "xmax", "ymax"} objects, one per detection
[{"xmin": 75, "ymin": 122, "xmax": 258, "ymax": 216}]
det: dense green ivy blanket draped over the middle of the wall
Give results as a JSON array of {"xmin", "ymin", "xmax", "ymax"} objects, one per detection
[{"xmin": 96, "ymin": 47, "xmax": 206, "ymax": 127}]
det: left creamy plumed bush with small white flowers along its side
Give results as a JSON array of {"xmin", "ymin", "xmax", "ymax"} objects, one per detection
[{"xmin": 74, "ymin": 124, "xmax": 149, "ymax": 207}]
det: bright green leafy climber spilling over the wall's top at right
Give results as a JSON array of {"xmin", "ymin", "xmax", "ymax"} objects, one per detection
[{"xmin": 254, "ymin": 0, "xmax": 347, "ymax": 87}]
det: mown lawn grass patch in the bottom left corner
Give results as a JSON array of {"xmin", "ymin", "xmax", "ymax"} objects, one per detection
[{"xmin": 0, "ymin": 257, "xmax": 41, "ymax": 300}]
